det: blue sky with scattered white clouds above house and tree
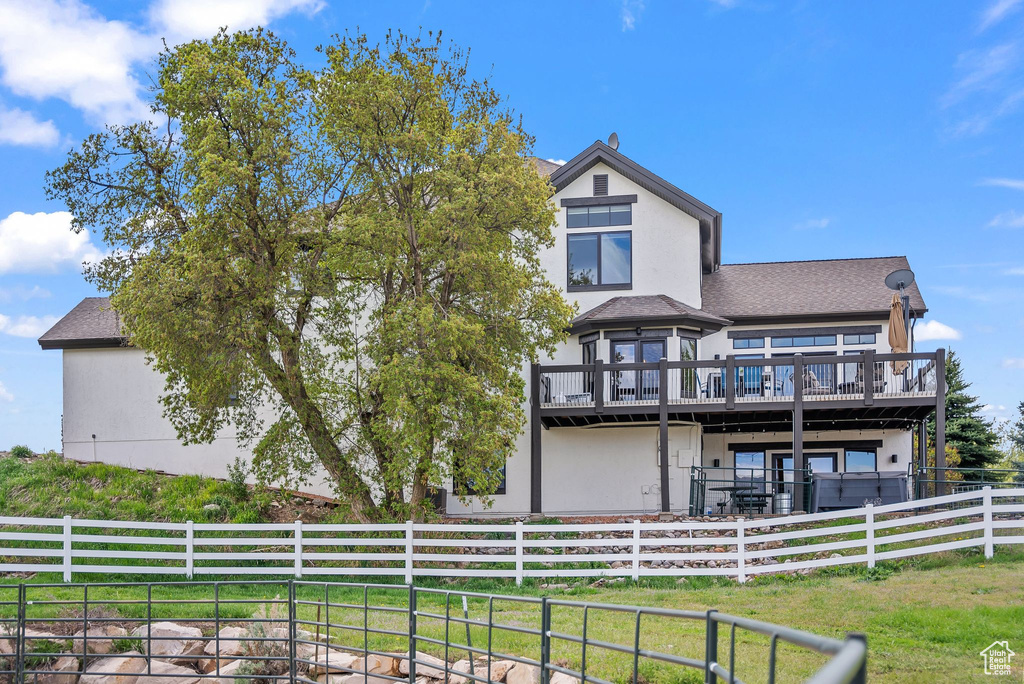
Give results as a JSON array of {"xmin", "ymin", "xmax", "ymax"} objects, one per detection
[{"xmin": 0, "ymin": 0, "xmax": 1024, "ymax": 451}]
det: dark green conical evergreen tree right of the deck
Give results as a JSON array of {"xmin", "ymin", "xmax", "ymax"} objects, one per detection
[{"xmin": 928, "ymin": 350, "xmax": 1000, "ymax": 468}]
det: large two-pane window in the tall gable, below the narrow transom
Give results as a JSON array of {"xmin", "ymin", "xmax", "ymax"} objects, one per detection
[{"xmin": 567, "ymin": 231, "xmax": 633, "ymax": 291}]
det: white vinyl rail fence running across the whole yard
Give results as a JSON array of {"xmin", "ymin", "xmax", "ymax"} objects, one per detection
[{"xmin": 0, "ymin": 487, "xmax": 1024, "ymax": 583}]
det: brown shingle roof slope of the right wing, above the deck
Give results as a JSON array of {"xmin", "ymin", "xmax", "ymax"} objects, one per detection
[{"xmin": 700, "ymin": 256, "xmax": 928, "ymax": 322}]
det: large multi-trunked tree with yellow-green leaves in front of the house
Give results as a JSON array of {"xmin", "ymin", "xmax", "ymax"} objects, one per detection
[{"xmin": 48, "ymin": 30, "xmax": 572, "ymax": 520}]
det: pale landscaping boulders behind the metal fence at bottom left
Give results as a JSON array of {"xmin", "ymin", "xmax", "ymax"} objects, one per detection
[{"xmin": 0, "ymin": 613, "xmax": 561, "ymax": 684}]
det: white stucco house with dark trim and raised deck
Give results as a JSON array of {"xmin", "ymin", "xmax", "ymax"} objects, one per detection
[{"xmin": 39, "ymin": 141, "xmax": 944, "ymax": 515}]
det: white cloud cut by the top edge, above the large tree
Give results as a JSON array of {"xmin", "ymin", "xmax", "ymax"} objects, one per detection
[{"xmin": 150, "ymin": 0, "xmax": 325, "ymax": 40}]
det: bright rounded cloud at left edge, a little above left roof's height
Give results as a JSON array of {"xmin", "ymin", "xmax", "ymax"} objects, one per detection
[{"xmin": 0, "ymin": 211, "xmax": 103, "ymax": 273}]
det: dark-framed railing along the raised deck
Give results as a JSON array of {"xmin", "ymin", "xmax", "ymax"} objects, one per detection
[{"xmin": 539, "ymin": 350, "xmax": 939, "ymax": 411}]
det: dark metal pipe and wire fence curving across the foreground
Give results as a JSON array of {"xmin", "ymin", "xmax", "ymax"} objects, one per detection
[{"xmin": 0, "ymin": 580, "xmax": 867, "ymax": 684}]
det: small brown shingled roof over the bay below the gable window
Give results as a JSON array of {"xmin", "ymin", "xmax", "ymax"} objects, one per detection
[{"xmin": 569, "ymin": 295, "xmax": 730, "ymax": 335}]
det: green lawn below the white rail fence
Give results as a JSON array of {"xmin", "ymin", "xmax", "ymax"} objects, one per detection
[{"xmin": 0, "ymin": 553, "xmax": 1024, "ymax": 683}]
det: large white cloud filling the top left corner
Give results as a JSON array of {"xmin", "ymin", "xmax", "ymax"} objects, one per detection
[{"xmin": 0, "ymin": 0, "xmax": 151, "ymax": 123}]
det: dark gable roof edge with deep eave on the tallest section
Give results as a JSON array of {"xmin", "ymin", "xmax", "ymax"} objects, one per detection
[{"xmin": 551, "ymin": 140, "xmax": 722, "ymax": 273}]
